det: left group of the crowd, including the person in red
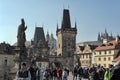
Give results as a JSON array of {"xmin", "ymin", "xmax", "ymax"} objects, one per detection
[{"xmin": 16, "ymin": 63, "xmax": 69, "ymax": 80}]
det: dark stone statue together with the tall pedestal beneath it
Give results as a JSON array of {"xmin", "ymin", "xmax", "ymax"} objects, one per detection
[{"xmin": 17, "ymin": 18, "xmax": 27, "ymax": 67}]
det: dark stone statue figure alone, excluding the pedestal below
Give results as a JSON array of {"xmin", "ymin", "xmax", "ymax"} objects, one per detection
[{"xmin": 17, "ymin": 18, "xmax": 27, "ymax": 47}]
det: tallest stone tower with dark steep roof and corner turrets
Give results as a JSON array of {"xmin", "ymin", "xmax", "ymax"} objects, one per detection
[{"xmin": 56, "ymin": 9, "xmax": 77, "ymax": 66}]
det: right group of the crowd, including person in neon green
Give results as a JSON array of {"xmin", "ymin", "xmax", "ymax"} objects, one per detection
[{"xmin": 73, "ymin": 62, "xmax": 120, "ymax": 80}]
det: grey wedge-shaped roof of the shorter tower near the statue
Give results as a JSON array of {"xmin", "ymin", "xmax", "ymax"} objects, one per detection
[{"xmin": 34, "ymin": 27, "xmax": 45, "ymax": 46}]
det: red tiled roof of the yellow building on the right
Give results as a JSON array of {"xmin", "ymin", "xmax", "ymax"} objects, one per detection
[{"xmin": 95, "ymin": 40, "xmax": 120, "ymax": 51}]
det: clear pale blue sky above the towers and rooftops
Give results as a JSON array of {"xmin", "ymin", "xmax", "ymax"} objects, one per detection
[{"xmin": 0, "ymin": 0, "xmax": 120, "ymax": 44}]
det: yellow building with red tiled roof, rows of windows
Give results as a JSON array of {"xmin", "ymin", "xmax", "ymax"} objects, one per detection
[{"xmin": 94, "ymin": 36, "xmax": 120, "ymax": 67}]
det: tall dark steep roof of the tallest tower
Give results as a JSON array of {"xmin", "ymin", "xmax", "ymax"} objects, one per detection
[{"xmin": 61, "ymin": 9, "xmax": 71, "ymax": 29}]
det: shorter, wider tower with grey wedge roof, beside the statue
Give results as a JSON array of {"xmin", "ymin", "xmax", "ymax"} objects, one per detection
[{"xmin": 30, "ymin": 27, "xmax": 49, "ymax": 58}]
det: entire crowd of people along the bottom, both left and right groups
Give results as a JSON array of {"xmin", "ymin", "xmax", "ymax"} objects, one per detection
[{"xmin": 16, "ymin": 62, "xmax": 120, "ymax": 80}]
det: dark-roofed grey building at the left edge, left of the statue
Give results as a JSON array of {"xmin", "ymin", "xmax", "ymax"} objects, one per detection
[{"xmin": 0, "ymin": 42, "xmax": 15, "ymax": 68}]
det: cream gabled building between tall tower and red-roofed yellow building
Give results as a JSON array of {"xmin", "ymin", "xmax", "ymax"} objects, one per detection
[{"xmin": 76, "ymin": 45, "xmax": 97, "ymax": 67}]
